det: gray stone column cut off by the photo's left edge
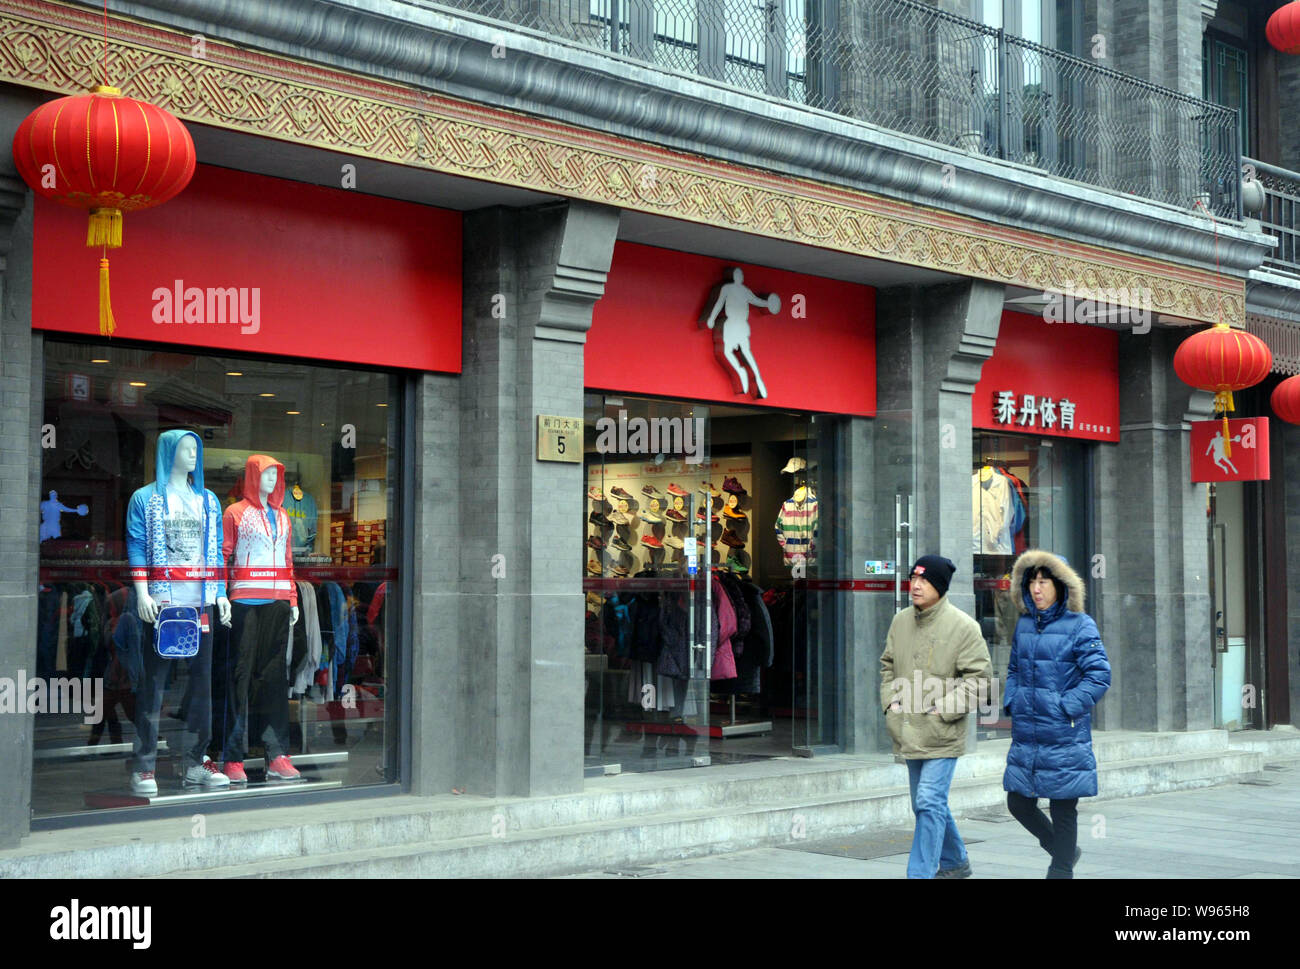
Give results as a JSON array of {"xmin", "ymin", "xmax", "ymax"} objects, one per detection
[{"xmin": 0, "ymin": 150, "xmax": 36, "ymax": 848}]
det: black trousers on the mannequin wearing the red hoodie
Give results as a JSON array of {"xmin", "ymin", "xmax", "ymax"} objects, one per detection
[{"xmin": 221, "ymin": 600, "xmax": 290, "ymax": 763}]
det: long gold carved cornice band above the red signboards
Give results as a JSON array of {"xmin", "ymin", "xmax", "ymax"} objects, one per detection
[{"xmin": 0, "ymin": 0, "xmax": 1245, "ymax": 324}]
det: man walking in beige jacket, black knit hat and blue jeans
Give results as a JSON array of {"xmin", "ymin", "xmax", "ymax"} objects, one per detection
[{"xmin": 880, "ymin": 555, "xmax": 992, "ymax": 878}]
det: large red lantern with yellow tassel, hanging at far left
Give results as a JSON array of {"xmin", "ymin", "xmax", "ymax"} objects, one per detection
[{"xmin": 13, "ymin": 85, "xmax": 195, "ymax": 336}]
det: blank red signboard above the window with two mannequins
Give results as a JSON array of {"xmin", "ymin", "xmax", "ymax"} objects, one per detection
[{"xmin": 31, "ymin": 165, "xmax": 462, "ymax": 373}]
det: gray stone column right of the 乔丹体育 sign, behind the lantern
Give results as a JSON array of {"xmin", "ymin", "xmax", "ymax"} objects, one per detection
[{"xmin": 1093, "ymin": 329, "xmax": 1214, "ymax": 730}]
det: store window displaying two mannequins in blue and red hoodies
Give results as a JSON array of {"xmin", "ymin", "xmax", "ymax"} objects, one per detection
[{"xmin": 33, "ymin": 337, "xmax": 400, "ymax": 818}]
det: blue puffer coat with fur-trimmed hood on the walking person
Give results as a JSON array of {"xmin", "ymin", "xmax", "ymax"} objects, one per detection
[{"xmin": 1002, "ymin": 549, "xmax": 1110, "ymax": 800}]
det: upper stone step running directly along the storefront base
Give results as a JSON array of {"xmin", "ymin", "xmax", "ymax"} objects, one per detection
[{"xmin": 0, "ymin": 731, "xmax": 1258, "ymax": 877}]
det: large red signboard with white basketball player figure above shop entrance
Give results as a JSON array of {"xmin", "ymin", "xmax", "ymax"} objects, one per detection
[{"xmin": 584, "ymin": 242, "xmax": 876, "ymax": 416}]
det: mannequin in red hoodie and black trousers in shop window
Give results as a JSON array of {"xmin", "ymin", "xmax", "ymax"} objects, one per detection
[{"xmin": 221, "ymin": 454, "xmax": 302, "ymax": 784}]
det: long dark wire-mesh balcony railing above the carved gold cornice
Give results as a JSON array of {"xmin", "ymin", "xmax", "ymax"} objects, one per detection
[{"xmin": 423, "ymin": 0, "xmax": 1240, "ymax": 219}]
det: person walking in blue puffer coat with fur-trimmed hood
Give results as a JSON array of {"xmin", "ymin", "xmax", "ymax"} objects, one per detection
[{"xmin": 1002, "ymin": 549, "xmax": 1110, "ymax": 878}]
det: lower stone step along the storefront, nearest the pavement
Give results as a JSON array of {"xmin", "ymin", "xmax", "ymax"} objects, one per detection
[{"xmin": 149, "ymin": 750, "xmax": 1262, "ymax": 878}]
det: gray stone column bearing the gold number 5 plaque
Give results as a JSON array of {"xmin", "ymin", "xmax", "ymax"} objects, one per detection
[{"xmin": 445, "ymin": 202, "xmax": 619, "ymax": 796}]
